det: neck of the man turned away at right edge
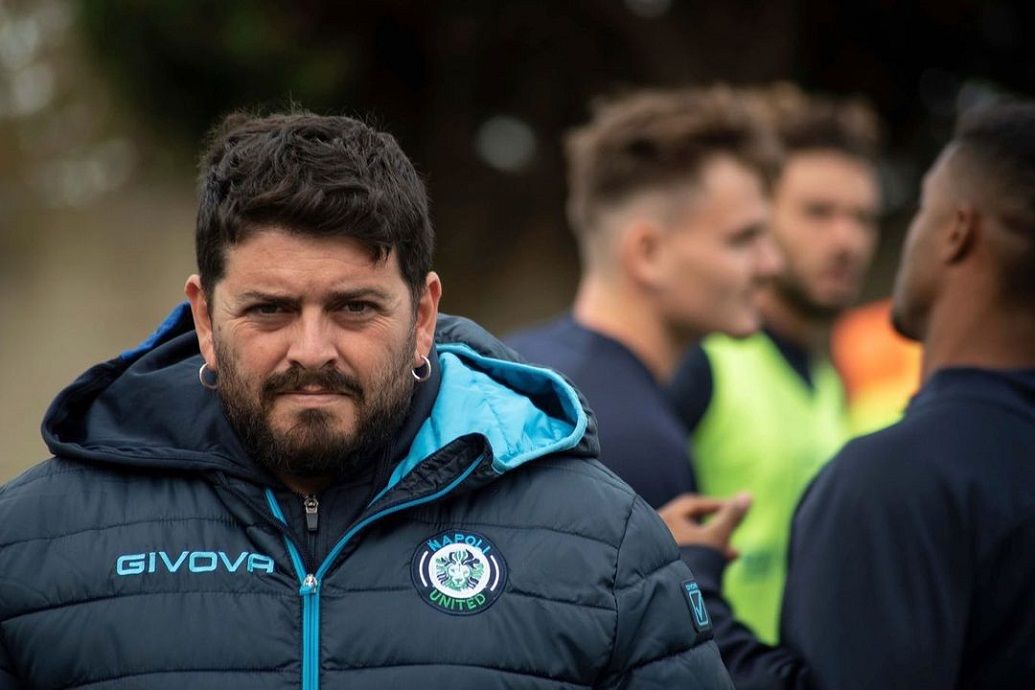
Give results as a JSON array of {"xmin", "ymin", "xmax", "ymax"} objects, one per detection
[{"xmin": 922, "ymin": 296, "xmax": 1035, "ymax": 381}]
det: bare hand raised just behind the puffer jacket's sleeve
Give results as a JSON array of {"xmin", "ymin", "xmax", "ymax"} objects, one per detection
[{"xmin": 657, "ymin": 493, "xmax": 751, "ymax": 560}]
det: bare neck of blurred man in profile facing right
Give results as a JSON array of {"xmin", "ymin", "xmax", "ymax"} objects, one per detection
[{"xmin": 572, "ymin": 274, "xmax": 698, "ymax": 384}]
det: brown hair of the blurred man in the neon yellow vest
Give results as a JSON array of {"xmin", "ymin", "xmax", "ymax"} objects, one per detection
[{"xmin": 743, "ymin": 82, "xmax": 881, "ymax": 163}]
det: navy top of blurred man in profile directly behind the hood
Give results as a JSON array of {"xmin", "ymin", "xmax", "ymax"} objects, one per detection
[{"xmin": 505, "ymin": 316, "xmax": 697, "ymax": 508}]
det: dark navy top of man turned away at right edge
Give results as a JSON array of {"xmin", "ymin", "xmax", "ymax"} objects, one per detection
[{"xmin": 684, "ymin": 368, "xmax": 1035, "ymax": 690}]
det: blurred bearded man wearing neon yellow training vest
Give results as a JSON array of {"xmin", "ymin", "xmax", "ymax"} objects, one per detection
[{"xmin": 672, "ymin": 84, "xmax": 879, "ymax": 641}]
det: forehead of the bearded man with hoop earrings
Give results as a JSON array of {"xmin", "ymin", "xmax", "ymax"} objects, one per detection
[{"xmin": 219, "ymin": 227, "xmax": 405, "ymax": 295}]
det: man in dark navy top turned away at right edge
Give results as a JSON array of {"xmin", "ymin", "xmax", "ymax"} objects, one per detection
[{"xmin": 678, "ymin": 103, "xmax": 1035, "ymax": 690}]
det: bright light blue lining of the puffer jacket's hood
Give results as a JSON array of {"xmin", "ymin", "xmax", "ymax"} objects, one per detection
[{"xmin": 375, "ymin": 344, "xmax": 588, "ymax": 501}]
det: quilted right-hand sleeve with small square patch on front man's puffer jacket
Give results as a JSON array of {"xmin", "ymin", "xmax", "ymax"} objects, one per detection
[{"xmin": 596, "ymin": 497, "xmax": 733, "ymax": 690}]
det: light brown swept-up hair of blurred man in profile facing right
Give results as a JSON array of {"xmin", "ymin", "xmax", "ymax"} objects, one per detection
[{"xmin": 564, "ymin": 86, "xmax": 779, "ymax": 243}]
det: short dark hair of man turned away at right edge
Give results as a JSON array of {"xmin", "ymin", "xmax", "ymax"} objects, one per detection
[{"xmin": 952, "ymin": 101, "xmax": 1035, "ymax": 302}]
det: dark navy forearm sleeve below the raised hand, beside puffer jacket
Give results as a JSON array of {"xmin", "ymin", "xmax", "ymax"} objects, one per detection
[{"xmin": 679, "ymin": 546, "xmax": 815, "ymax": 690}]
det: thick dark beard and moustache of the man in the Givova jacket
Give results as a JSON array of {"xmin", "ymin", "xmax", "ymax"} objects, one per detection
[{"xmin": 216, "ymin": 339, "xmax": 413, "ymax": 477}]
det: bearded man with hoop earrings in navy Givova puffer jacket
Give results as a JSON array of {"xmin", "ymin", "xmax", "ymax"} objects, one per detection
[{"xmin": 0, "ymin": 113, "xmax": 731, "ymax": 690}]
